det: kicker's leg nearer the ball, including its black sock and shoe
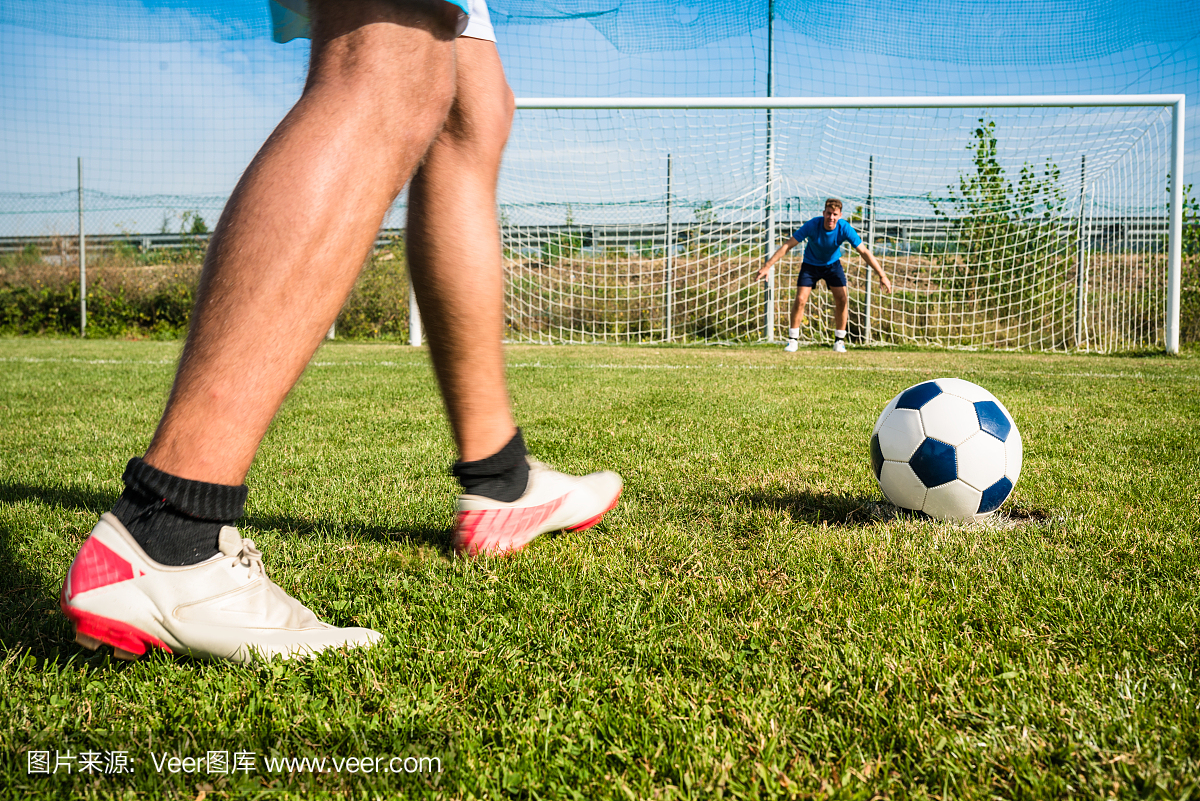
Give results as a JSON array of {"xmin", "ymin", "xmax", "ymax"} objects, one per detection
[{"xmin": 407, "ymin": 31, "xmax": 620, "ymax": 554}]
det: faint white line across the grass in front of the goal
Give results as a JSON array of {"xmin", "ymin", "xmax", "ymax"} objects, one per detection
[{"xmin": 0, "ymin": 356, "xmax": 1200, "ymax": 381}]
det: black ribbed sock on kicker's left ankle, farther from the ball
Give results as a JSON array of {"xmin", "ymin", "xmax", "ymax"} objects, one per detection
[{"xmin": 113, "ymin": 457, "xmax": 248, "ymax": 566}]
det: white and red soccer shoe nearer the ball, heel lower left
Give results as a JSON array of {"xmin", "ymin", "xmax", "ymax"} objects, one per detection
[{"xmin": 454, "ymin": 459, "xmax": 622, "ymax": 556}]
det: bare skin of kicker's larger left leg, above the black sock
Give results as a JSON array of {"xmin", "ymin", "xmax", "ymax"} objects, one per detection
[{"xmin": 145, "ymin": 0, "xmax": 455, "ymax": 484}]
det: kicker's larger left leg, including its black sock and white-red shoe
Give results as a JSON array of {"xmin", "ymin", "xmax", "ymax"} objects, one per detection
[{"xmin": 61, "ymin": 0, "xmax": 456, "ymax": 660}]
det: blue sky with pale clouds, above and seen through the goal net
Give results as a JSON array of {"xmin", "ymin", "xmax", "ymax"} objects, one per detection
[{"xmin": 0, "ymin": 0, "xmax": 1200, "ymax": 235}]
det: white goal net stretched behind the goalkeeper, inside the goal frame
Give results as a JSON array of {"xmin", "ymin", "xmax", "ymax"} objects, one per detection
[{"xmin": 500, "ymin": 101, "xmax": 1171, "ymax": 351}]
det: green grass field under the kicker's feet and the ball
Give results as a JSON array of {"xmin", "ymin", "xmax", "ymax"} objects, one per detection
[{"xmin": 0, "ymin": 339, "xmax": 1200, "ymax": 800}]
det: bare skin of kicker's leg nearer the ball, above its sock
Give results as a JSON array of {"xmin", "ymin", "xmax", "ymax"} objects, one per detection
[{"xmin": 407, "ymin": 37, "xmax": 516, "ymax": 462}]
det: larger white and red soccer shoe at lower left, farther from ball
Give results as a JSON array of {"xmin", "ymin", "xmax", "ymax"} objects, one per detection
[{"xmin": 59, "ymin": 512, "xmax": 383, "ymax": 662}]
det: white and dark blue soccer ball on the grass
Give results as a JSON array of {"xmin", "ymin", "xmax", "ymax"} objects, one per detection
[{"xmin": 871, "ymin": 378, "xmax": 1021, "ymax": 520}]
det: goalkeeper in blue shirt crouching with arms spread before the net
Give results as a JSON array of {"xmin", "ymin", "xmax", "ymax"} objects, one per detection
[{"xmin": 757, "ymin": 198, "xmax": 892, "ymax": 354}]
